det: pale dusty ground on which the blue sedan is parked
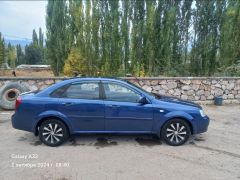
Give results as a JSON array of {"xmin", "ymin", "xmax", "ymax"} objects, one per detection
[{"xmin": 0, "ymin": 105, "xmax": 240, "ymax": 180}]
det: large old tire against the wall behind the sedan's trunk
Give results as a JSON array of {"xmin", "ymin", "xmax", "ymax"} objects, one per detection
[{"xmin": 0, "ymin": 82, "xmax": 29, "ymax": 110}]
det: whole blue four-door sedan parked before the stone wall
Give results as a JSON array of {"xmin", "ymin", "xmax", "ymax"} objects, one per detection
[{"xmin": 12, "ymin": 78, "xmax": 209, "ymax": 146}]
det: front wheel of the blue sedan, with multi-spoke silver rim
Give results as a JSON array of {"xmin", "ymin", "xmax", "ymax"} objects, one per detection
[{"xmin": 161, "ymin": 119, "xmax": 191, "ymax": 146}]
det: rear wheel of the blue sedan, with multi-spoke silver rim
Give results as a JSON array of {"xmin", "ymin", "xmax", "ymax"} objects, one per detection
[{"xmin": 39, "ymin": 119, "xmax": 69, "ymax": 147}]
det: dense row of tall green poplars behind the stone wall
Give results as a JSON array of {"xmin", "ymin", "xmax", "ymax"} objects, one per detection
[{"xmin": 45, "ymin": 0, "xmax": 240, "ymax": 76}]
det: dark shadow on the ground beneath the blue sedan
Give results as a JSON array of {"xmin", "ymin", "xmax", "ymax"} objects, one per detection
[{"xmin": 22, "ymin": 133, "xmax": 205, "ymax": 149}]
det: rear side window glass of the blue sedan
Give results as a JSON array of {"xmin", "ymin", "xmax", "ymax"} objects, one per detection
[{"xmin": 51, "ymin": 82, "xmax": 99, "ymax": 99}]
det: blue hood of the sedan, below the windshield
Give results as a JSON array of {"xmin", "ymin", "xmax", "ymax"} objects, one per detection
[{"xmin": 158, "ymin": 95, "xmax": 202, "ymax": 109}]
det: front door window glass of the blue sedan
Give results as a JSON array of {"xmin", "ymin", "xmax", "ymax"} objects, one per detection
[{"xmin": 103, "ymin": 83, "xmax": 141, "ymax": 103}]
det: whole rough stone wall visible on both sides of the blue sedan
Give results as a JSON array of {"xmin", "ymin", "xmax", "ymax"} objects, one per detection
[{"xmin": 0, "ymin": 77, "xmax": 240, "ymax": 104}]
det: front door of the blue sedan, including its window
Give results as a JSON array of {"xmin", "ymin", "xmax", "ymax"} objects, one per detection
[{"xmin": 103, "ymin": 81, "xmax": 153, "ymax": 132}]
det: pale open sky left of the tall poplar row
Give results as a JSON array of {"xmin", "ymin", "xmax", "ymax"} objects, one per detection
[{"xmin": 0, "ymin": 0, "xmax": 47, "ymax": 40}]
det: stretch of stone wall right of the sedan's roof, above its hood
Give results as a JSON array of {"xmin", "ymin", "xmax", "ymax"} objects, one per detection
[{"xmin": 125, "ymin": 77, "xmax": 240, "ymax": 103}]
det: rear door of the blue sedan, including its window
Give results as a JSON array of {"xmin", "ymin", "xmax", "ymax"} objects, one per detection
[{"xmin": 58, "ymin": 81, "xmax": 104, "ymax": 132}]
